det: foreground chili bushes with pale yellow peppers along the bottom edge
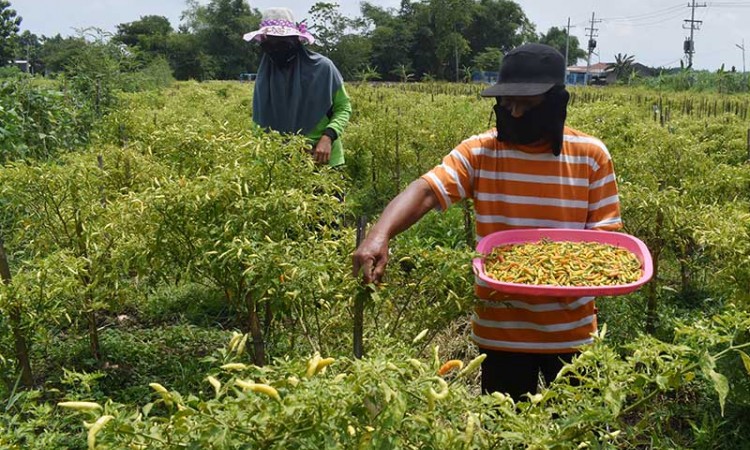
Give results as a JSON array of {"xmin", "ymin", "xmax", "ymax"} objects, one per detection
[{"xmin": 50, "ymin": 312, "xmax": 750, "ymax": 449}]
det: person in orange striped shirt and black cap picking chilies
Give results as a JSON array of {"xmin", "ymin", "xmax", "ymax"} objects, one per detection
[{"xmin": 353, "ymin": 44, "xmax": 622, "ymax": 400}]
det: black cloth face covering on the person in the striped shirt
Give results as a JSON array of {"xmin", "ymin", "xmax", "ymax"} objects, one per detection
[{"xmin": 495, "ymin": 86, "xmax": 570, "ymax": 156}]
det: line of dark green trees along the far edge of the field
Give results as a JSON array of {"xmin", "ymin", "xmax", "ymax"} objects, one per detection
[{"xmin": 0, "ymin": 0, "xmax": 585, "ymax": 81}]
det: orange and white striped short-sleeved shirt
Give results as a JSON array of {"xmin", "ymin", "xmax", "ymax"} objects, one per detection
[{"xmin": 422, "ymin": 127, "xmax": 622, "ymax": 353}]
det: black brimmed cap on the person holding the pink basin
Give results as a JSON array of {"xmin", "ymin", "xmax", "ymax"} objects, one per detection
[{"xmin": 481, "ymin": 44, "xmax": 565, "ymax": 97}]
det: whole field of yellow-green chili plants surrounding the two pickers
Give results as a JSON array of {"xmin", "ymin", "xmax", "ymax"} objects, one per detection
[{"xmin": 0, "ymin": 82, "xmax": 750, "ymax": 449}]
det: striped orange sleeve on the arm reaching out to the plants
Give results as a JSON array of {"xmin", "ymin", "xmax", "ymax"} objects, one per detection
[{"xmin": 422, "ymin": 141, "xmax": 474, "ymax": 211}]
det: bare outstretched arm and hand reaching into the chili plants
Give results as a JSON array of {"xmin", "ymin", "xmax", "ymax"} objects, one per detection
[{"xmin": 352, "ymin": 178, "xmax": 440, "ymax": 283}]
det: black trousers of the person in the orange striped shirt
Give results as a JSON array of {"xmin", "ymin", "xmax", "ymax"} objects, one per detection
[{"xmin": 480, "ymin": 348, "xmax": 576, "ymax": 402}]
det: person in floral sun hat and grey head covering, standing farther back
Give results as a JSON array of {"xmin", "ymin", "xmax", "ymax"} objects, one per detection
[{"xmin": 243, "ymin": 8, "xmax": 352, "ymax": 167}]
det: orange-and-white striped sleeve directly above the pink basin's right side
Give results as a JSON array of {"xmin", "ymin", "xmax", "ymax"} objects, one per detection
[{"xmin": 586, "ymin": 149, "xmax": 622, "ymax": 231}]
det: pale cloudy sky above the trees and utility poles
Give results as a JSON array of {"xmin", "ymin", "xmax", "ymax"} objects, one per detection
[{"xmin": 10, "ymin": 0, "xmax": 750, "ymax": 71}]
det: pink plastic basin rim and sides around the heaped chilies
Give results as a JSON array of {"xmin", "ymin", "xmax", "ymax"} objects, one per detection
[{"xmin": 473, "ymin": 228, "xmax": 654, "ymax": 297}]
